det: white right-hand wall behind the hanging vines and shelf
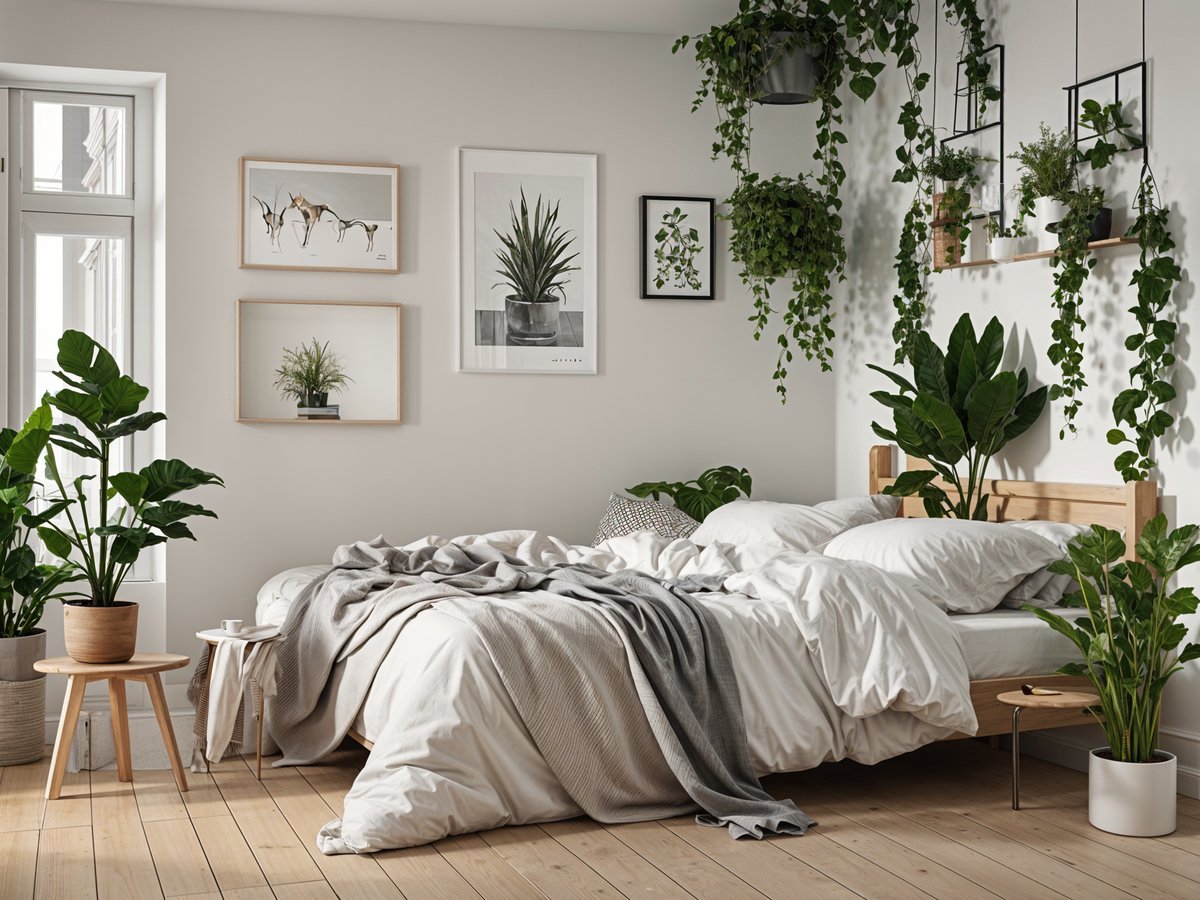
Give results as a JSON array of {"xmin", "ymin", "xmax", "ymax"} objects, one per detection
[{"xmin": 835, "ymin": 0, "xmax": 1200, "ymax": 793}]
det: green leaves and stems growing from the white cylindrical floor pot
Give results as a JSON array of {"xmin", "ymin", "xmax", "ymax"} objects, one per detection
[{"xmin": 1025, "ymin": 515, "xmax": 1200, "ymax": 762}]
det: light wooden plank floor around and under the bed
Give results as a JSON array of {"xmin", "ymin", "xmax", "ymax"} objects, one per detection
[{"xmin": 0, "ymin": 740, "xmax": 1200, "ymax": 900}]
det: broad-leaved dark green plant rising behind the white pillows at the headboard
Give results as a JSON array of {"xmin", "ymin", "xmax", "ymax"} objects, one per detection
[{"xmin": 870, "ymin": 313, "xmax": 1048, "ymax": 520}]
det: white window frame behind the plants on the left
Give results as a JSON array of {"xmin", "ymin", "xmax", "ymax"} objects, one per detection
[{"xmin": 0, "ymin": 82, "xmax": 159, "ymax": 582}]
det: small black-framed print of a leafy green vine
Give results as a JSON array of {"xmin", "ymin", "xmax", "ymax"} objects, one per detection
[{"xmin": 641, "ymin": 194, "xmax": 716, "ymax": 300}]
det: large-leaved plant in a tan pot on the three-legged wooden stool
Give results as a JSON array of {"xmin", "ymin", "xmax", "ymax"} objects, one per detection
[{"xmin": 37, "ymin": 331, "xmax": 224, "ymax": 662}]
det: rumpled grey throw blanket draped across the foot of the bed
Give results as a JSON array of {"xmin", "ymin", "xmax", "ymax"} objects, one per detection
[{"xmin": 271, "ymin": 539, "xmax": 814, "ymax": 838}]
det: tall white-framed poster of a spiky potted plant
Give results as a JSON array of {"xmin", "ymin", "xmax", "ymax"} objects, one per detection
[{"xmin": 457, "ymin": 148, "xmax": 598, "ymax": 374}]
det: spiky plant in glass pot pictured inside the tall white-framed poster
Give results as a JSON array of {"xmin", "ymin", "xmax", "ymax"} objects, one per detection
[{"xmin": 493, "ymin": 188, "xmax": 580, "ymax": 344}]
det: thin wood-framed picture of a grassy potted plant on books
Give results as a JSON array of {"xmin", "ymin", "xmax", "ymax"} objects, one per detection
[{"xmin": 236, "ymin": 300, "xmax": 401, "ymax": 425}]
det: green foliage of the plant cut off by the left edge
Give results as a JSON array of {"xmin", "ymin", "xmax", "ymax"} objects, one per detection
[{"xmin": 0, "ymin": 406, "xmax": 74, "ymax": 638}]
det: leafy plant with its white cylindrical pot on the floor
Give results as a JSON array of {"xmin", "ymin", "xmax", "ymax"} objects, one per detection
[{"xmin": 1025, "ymin": 514, "xmax": 1200, "ymax": 838}]
